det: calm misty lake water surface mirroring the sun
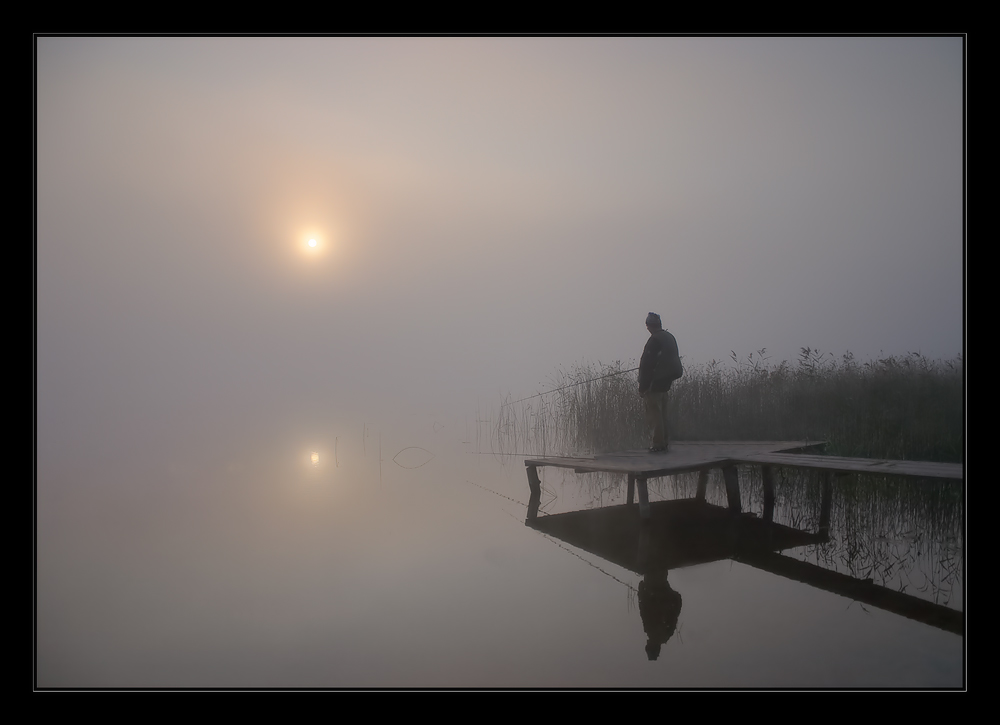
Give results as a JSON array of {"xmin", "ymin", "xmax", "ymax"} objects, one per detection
[{"xmin": 37, "ymin": 416, "xmax": 964, "ymax": 688}]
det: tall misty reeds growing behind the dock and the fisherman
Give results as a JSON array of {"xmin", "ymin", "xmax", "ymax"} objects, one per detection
[{"xmin": 490, "ymin": 347, "xmax": 964, "ymax": 463}]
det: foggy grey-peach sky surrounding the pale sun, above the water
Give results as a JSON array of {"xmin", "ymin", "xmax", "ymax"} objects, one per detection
[{"xmin": 37, "ymin": 37, "xmax": 964, "ymax": 460}]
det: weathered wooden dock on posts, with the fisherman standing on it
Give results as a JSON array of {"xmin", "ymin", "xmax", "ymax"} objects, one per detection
[{"xmin": 524, "ymin": 441, "xmax": 965, "ymax": 522}]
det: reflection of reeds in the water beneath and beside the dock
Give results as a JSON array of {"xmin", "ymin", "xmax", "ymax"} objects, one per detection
[{"xmin": 543, "ymin": 466, "xmax": 964, "ymax": 609}]
